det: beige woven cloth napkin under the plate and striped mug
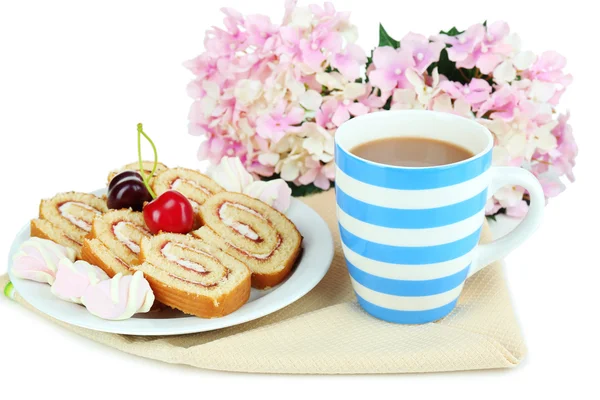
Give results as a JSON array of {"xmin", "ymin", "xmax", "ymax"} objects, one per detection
[{"xmin": 0, "ymin": 191, "xmax": 526, "ymax": 374}]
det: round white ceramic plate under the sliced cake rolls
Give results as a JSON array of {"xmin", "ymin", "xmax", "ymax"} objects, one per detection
[{"xmin": 8, "ymin": 191, "xmax": 333, "ymax": 336}]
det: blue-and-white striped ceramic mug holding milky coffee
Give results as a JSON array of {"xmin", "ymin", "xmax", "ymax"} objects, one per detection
[{"xmin": 335, "ymin": 110, "xmax": 545, "ymax": 324}]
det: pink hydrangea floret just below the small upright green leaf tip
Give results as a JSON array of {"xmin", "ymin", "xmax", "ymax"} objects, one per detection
[{"xmin": 369, "ymin": 46, "xmax": 415, "ymax": 91}]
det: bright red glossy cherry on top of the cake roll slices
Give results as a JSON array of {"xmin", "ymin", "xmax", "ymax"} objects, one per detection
[{"xmin": 144, "ymin": 190, "xmax": 194, "ymax": 234}]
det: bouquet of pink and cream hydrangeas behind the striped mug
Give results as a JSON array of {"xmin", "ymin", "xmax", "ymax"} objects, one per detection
[{"xmin": 185, "ymin": 0, "xmax": 577, "ymax": 217}]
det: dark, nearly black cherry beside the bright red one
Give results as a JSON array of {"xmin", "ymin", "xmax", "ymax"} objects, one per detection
[{"xmin": 107, "ymin": 171, "xmax": 152, "ymax": 211}]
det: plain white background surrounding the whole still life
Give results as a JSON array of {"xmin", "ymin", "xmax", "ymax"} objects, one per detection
[{"xmin": 0, "ymin": 0, "xmax": 600, "ymax": 400}]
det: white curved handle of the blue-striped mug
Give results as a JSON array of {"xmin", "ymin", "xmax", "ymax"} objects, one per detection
[{"xmin": 468, "ymin": 167, "xmax": 546, "ymax": 277}]
